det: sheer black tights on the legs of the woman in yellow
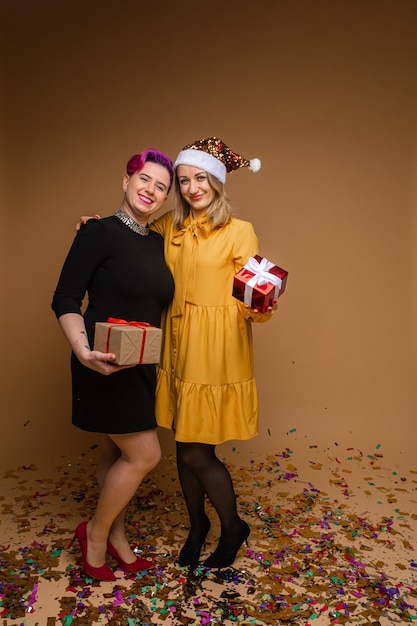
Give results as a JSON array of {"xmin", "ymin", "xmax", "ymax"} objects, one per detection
[{"xmin": 177, "ymin": 442, "xmax": 241, "ymax": 535}]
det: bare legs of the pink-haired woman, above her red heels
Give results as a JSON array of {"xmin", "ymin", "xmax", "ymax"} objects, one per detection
[{"xmin": 87, "ymin": 430, "xmax": 161, "ymax": 567}]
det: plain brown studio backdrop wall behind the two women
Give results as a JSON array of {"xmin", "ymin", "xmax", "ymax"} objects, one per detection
[{"xmin": 0, "ymin": 0, "xmax": 417, "ymax": 466}]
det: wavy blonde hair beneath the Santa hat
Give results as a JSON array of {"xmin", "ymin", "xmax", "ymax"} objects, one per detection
[{"xmin": 172, "ymin": 172, "xmax": 232, "ymax": 229}]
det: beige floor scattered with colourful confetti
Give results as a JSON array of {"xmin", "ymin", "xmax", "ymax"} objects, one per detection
[{"xmin": 0, "ymin": 446, "xmax": 417, "ymax": 626}]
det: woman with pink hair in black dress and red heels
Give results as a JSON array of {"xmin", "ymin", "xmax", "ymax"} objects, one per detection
[{"xmin": 52, "ymin": 149, "xmax": 174, "ymax": 581}]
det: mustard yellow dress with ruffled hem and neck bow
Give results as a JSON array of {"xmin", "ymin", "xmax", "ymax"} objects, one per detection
[{"xmin": 151, "ymin": 213, "xmax": 270, "ymax": 444}]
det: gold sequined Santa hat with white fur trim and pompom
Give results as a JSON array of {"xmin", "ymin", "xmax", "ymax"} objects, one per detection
[{"xmin": 174, "ymin": 137, "xmax": 261, "ymax": 184}]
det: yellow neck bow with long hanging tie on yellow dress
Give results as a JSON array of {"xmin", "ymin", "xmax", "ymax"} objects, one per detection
[{"xmin": 171, "ymin": 215, "xmax": 211, "ymax": 316}]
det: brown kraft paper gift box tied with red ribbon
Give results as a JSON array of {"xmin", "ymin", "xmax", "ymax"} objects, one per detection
[{"xmin": 94, "ymin": 318, "xmax": 162, "ymax": 365}]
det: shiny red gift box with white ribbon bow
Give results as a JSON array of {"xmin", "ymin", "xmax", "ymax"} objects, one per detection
[{"xmin": 233, "ymin": 254, "xmax": 288, "ymax": 313}]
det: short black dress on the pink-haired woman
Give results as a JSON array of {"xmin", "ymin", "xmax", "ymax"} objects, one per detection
[{"xmin": 52, "ymin": 216, "xmax": 174, "ymax": 434}]
